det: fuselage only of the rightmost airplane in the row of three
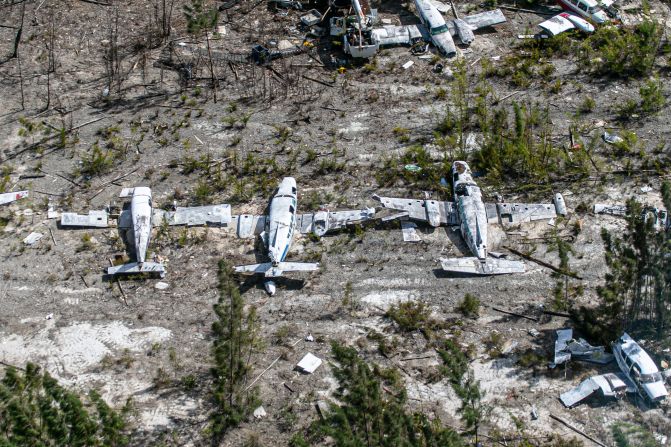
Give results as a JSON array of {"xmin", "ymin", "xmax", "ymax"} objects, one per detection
[{"xmin": 452, "ymin": 161, "xmax": 487, "ymax": 261}]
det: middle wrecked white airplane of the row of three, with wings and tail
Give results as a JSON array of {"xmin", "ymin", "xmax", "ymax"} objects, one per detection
[{"xmin": 233, "ymin": 177, "xmax": 375, "ymax": 295}]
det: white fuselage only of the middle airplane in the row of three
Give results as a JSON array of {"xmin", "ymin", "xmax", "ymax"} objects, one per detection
[{"xmin": 266, "ymin": 177, "xmax": 298, "ymax": 266}]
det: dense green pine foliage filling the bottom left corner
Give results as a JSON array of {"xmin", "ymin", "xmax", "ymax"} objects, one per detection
[{"xmin": 0, "ymin": 363, "xmax": 131, "ymax": 447}]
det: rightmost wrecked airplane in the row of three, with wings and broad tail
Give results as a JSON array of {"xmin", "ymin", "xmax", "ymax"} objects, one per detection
[{"xmin": 374, "ymin": 161, "xmax": 567, "ymax": 275}]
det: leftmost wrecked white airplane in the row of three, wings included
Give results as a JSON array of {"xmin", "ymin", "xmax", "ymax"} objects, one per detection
[{"xmin": 61, "ymin": 186, "xmax": 231, "ymax": 277}]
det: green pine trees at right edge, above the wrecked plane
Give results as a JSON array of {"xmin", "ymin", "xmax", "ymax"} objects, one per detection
[{"xmin": 574, "ymin": 182, "xmax": 671, "ymax": 342}]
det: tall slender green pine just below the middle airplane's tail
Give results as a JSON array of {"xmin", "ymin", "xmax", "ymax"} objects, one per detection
[{"xmin": 210, "ymin": 259, "xmax": 260, "ymax": 439}]
